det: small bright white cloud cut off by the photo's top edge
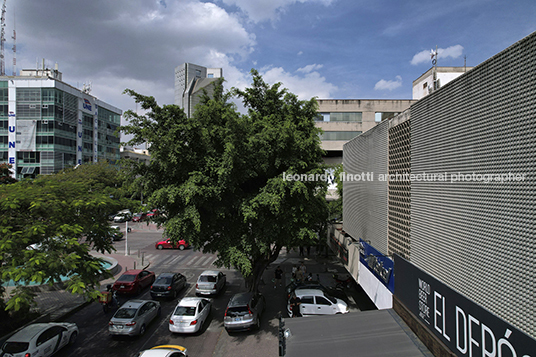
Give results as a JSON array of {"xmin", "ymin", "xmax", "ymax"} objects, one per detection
[{"xmin": 222, "ymin": 0, "xmax": 335, "ymax": 22}]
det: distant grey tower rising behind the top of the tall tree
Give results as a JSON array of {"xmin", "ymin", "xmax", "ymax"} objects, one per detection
[{"xmin": 175, "ymin": 63, "xmax": 223, "ymax": 117}]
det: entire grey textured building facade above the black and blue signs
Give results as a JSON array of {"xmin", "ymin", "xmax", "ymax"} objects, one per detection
[{"xmin": 343, "ymin": 33, "xmax": 536, "ymax": 342}]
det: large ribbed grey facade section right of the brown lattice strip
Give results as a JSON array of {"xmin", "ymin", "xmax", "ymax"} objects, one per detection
[{"xmin": 410, "ymin": 33, "xmax": 536, "ymax": 337}]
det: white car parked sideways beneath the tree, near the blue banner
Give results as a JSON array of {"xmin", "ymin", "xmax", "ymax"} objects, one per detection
[{"xmin": 287, "ymin": 289, "xmax": 348, "ymax": 316}]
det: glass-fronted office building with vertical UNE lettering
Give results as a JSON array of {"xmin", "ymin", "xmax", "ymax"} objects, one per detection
[{"xmin": 0, "ymin": 68, "xmax": 122, "ymax": 179}]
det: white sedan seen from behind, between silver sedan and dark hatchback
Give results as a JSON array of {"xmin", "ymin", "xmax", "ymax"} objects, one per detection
[{"xmin": 169, "ymin": 297, "xmax": 212, "ymax": 333}]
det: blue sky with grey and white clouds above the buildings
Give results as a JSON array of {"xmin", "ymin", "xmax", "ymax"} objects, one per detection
[{"xmin": 5, "ymin": 0, "xmax": 536, "ymax": 119}]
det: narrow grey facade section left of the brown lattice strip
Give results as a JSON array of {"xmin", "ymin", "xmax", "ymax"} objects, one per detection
[{"xmin": 343, "ymin": 121, "xmax": 389, "ymax": 254}]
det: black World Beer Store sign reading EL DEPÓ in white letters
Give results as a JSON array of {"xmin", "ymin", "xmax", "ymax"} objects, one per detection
[{"xmin": 394, "ymin": 254, "xmax": 536, "ymax": 357}]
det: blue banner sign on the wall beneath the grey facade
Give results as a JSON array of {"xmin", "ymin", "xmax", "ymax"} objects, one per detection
[{"xmin": 359, "ymin": 239, "xmax": 395, "ymax": 294}]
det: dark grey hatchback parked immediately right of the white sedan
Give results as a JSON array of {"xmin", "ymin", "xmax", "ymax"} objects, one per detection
[{"xmin": 223, "ymin": 292, "xmax": 266, "ymax": 332}]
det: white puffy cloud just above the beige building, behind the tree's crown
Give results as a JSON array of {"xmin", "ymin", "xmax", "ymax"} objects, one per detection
[{"xmin": 259, "ymin": 67, "xmax": 338, "ymax": 100}]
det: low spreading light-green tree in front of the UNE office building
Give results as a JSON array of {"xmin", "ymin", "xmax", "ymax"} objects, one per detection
[{"xmin": 0, "ymin": 163, "xmax": 127, "ymax": 310}]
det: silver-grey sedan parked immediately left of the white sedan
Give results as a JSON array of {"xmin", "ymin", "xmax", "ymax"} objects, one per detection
[{"xmin": 108, "ymin": 300, "xmax": 161, "ymax": 336}]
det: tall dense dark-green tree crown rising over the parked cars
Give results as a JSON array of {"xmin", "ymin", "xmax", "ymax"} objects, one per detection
[{"xmin": 121, "ymin": 70, "xmax": 327, "ymax": 290}]
